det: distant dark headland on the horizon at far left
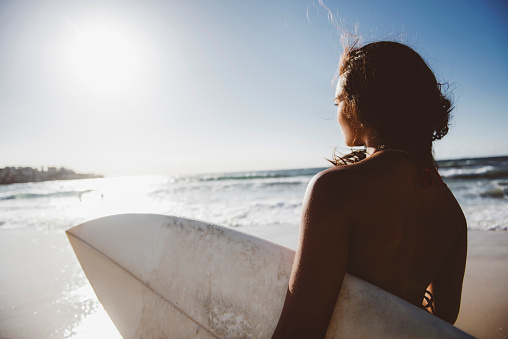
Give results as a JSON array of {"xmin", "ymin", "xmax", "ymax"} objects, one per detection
[{"xmin": 0, "ymin": 167, "xmax": 104, "ymax": 185}]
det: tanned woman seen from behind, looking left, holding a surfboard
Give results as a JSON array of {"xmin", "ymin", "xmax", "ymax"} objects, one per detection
[{"xmin": 273, "ymin": 41, "xmax": 467, "ymax": 338}]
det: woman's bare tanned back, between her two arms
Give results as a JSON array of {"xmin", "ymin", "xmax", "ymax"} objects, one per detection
[{"xmin": 347, "ymin": 151, "xmax": 467, "ymax": 313}]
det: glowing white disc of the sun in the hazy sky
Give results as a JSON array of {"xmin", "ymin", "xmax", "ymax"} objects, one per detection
[{"xmin": 69, "ymin": 27, "xmax": 139, "ymax": 93}]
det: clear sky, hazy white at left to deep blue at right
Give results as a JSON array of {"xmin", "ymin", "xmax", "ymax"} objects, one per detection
[{"xmin": 0, "ymin": 0, "xmax": 508, "ymax": 176}]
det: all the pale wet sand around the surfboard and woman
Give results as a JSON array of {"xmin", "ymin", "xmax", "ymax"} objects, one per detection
[{"xmin": 0, "ymin": 225, "xmax": 508, "ymax": 338}]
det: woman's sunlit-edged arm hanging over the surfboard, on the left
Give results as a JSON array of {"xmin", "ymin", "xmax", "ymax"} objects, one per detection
[{"xmin": 273, "ymin": 172, "xmax": 349, "ymax": 338}]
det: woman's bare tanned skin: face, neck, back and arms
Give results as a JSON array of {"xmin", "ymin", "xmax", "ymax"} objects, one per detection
[{"xmin": 273, "ymin": 75, "xmax": 467, "ymax": 338}]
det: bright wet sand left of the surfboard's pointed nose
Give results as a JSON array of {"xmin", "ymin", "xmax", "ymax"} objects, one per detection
[{"xmin": 0, "ymin": 230, "xmax": 120, "ymax": 338}]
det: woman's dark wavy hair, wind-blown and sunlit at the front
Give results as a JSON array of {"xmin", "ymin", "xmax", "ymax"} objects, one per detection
[{"xmin": 331, "ymin": 41, "xmax": 453, "ymax": 165}]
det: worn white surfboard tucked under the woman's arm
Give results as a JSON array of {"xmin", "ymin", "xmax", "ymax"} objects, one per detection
[{"xmin": 67, "ymin": 214, "xmax": 470, "ymax": 338}]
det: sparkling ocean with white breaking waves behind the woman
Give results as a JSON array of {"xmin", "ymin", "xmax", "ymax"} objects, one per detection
[{"xmin": 0, "ymin": 156, "xmax": 508, "ymax": 231}]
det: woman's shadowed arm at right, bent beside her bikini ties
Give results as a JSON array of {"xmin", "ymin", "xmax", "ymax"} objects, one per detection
[{"xmin": 429, "ymin": 225, "xmax": 467, "ymax": 325}]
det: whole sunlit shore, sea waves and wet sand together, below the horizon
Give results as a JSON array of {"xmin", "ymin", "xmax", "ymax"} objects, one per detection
[{"xmin": 0, "ymin": 157, "xmax": 508, "ymax": 338}]
